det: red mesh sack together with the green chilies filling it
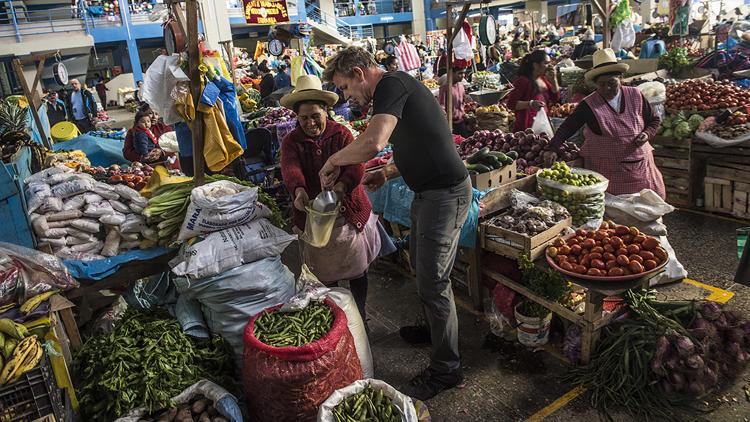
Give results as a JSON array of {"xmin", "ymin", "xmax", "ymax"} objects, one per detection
[{"xmin": 243, "ymin": 299, "xmax": 362, "ymax": 422}]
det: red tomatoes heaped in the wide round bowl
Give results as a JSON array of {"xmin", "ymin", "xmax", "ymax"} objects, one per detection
[{"xmin": 547, "ymin": 222, "xmax": 669, "ymax": 277}]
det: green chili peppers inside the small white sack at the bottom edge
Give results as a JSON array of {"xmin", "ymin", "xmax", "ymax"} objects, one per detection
[{"xmin": 333, "ymin": 385, "xmax": 402, "ymax": 422}]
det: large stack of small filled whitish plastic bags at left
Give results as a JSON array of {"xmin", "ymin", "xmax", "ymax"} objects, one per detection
[{"xmin": 25, "ymin": 166, "xmax": 158, "ymax": 260}]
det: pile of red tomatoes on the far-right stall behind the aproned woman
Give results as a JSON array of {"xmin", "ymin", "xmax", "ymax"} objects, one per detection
[{"xmin": 665, "ymin": 79, "xmax": 750, "ymax": 111}]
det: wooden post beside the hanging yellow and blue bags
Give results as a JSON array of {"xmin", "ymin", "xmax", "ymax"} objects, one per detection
[{"xmin": 185, "ymin": 0, "xmax": 205, "ymax": 186}]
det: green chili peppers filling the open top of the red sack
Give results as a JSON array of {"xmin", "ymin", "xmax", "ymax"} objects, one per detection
[{"xmin": 253, "ymin": 303, "xmax": 333, "ymax": 347}]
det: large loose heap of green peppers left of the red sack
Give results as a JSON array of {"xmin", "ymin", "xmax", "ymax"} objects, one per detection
[{"xmin": 73, "ymin": 310, "xmax": 233, "ymax": 421}]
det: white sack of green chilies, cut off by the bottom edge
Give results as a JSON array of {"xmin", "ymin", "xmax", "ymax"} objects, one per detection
[{"xmin": 318, "ymin": 379, "xmax": 419, "ymax": 422}]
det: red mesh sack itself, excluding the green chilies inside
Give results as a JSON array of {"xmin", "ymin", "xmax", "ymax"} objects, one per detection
[{"xmin": 242, "ymin": 298, "xmax": 362, "ymax": 422}]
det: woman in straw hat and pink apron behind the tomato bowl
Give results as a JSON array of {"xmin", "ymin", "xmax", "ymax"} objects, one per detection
[{"xmin": 545, "ymin": 48, "xmax": 666, "ymax": 198}]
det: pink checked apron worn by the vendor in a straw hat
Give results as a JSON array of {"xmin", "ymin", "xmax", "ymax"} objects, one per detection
[{"xmin": 581, "ymin": 86, "xmax": 666, "ymax": 198}]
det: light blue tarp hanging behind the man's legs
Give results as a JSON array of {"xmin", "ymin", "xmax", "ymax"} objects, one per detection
[{"xmin": 367, "ymin": 177, "xmax": 486, "ymax": 248}]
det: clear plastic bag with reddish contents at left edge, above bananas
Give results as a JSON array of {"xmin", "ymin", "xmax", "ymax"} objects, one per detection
[{"xmin": 0, "ymin": 242, "xmax": 78, "ymax": 305}]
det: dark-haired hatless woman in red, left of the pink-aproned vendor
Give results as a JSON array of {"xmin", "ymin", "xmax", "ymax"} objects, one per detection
[{"xmin": 507, "ymin": 50, "xmax": 560, "ymax": 132}]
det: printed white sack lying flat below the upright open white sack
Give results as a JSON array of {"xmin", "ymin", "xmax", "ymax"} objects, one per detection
[{"xmin": 170, "ymin": 218, "xmax": 297, "ymax": 278}]
